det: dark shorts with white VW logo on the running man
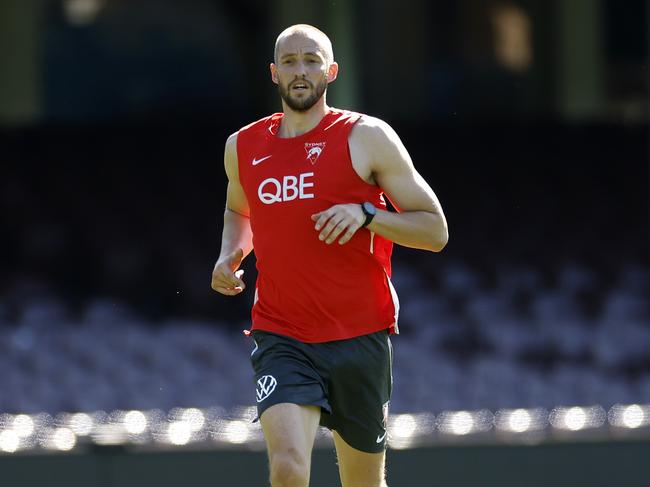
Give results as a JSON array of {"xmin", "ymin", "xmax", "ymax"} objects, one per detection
[{"xmin": 251, "ymin": 330, "xmax": 393, "ymax": 453}]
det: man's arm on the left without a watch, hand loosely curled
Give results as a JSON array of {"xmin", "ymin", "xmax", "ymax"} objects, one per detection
[{"xmin": 212, "ymin": 133, "xmax": 253, "ymax": 296}]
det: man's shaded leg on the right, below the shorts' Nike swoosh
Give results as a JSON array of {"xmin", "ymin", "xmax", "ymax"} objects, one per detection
[{"xmin": 332, "ymin": 431, "xmax": 387, "ymax": 487}]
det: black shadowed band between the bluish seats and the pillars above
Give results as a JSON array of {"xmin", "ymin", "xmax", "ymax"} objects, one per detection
[{"xmin": 0, "ymin": 120, "xmax": 648, "ymax": 319}]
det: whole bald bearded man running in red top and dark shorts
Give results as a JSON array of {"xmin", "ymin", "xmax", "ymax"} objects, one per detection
[{"xmin": 212, "ymin": 24, "xmax": 448, "ymax": 487}]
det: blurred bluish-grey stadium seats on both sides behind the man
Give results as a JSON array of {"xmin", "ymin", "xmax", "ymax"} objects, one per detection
[{"xmin": 0, "ymin": 262, "xmax": 650, "ymax": 413}]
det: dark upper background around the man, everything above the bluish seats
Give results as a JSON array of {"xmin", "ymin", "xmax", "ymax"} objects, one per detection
[{"xmin": 0, "ymin": 0, "xmax": 649, "ymax": 321}]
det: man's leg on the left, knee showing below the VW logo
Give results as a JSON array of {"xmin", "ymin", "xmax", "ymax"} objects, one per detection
[{"xmin": 260, "ymin": 403, "xmax": 320, "ymax": 487}]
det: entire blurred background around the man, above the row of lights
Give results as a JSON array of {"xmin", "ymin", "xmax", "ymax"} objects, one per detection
[{"xmin": 0, "ymin": 0, "xmax": 650, "ymax": 428}]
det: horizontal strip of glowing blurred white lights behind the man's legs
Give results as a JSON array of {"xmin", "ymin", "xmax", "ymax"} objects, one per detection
[{"xmin": 0, "ymin": 404, "xmax": 650, "ymax": 453}]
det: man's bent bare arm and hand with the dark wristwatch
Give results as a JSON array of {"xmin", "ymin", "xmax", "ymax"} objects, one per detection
[{"xmin": 312, "ymin": 117, "xmax": 449, "ymax": 252}]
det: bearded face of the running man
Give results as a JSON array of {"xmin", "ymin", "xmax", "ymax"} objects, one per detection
[{"xmin": 275, "ymin": 34, "xmax": 329, "ymax": 112}]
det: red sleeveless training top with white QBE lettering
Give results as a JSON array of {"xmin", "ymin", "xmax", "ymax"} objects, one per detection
[{"xmin": 237, "ymin": 108, "xmax": 399, "ymax": 343}]
